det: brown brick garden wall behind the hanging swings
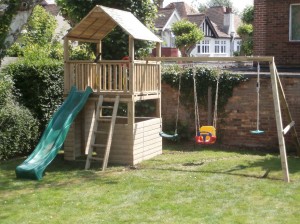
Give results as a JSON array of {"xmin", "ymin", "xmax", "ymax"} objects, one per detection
[{"xmin": 162, "ymin": 76, "xmax": 300, "ymax": 150}]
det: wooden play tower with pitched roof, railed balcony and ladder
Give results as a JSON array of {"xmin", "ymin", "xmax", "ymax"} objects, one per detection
[{"xmin": 64, "ymin": 6, "xmax": 162, "ymax": 165}]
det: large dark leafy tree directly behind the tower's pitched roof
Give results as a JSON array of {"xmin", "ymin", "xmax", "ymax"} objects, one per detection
[{"xmin": 56, "ymin": 0, "xmax": 157, "ymax": 59}]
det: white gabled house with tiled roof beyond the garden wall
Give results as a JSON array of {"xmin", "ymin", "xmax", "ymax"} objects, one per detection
[{"xmin": 155, "ymin": 2, "xmax": 241, "ymax": 57}]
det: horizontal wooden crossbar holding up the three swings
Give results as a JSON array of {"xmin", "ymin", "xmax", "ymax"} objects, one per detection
[{"xmin": 146, "ymin": 56, "xmax": 274, "ymax": 63}]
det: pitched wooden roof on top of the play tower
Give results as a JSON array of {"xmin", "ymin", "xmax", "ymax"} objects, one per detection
[{"xmin": 66, "ymin": 5, "xmax": 162, "ymax": 42}]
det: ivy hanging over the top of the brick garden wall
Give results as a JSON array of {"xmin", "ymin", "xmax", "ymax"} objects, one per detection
[{"xmin": 162, "ymin": 65, "xmax": 247, "ymax": 111}]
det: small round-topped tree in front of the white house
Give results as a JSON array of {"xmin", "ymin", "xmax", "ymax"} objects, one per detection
[{"xmin": 172, "ymin": 19, "xmax": 204, "ymax": 57}]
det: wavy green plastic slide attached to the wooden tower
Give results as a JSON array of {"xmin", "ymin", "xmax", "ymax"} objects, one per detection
[{"xmin": 16, "ymin": 86, "xmax": 93, "ymax": 180}]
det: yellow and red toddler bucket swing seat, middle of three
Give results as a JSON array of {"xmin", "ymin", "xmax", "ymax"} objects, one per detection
[{"xmin": 195, "ymin": 126, "xmax": 217, "ymax": 145}]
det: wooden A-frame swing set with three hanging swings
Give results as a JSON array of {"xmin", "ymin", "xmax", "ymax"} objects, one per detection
[{"xmin": 147, "ymin": 56, "xmax": 300, "ymax": 182}]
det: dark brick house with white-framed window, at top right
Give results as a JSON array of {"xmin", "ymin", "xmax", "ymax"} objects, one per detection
[{"xmin": 253, "ymin": 0, "xmax": 300, "ymax": 67}]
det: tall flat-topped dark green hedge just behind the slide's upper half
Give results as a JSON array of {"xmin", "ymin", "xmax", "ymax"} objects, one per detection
[{"xmin": 5, "ymin": 60, "xmax": 63, "ymax": 131}]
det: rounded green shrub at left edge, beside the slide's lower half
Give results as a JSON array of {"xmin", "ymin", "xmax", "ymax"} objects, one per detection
[{"xmin": 0, "ymin": 101, "xmax": 39, "ymax": 160}]
